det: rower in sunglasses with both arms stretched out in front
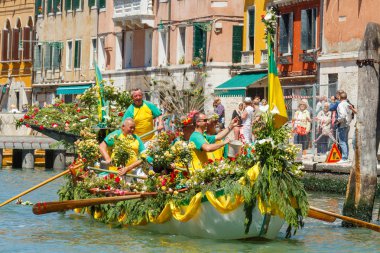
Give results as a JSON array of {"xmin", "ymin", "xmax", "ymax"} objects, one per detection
[{"xmin": 189, "ymin": 113, "xmax": 238, "ymax": 170}]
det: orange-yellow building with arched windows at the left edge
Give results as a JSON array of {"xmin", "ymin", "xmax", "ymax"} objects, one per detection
[{"xmin": 0, "ymin": 0, "xmax": 35, "ymax": 112}]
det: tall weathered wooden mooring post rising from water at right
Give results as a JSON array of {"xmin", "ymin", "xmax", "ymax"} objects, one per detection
[{"xmin": 343, "ymin": 23, "xmax": 380, "ymax": 226}]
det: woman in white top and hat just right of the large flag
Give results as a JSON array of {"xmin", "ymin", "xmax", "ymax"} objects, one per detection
[{"xmin": 293, "ymin": 101, "xmax": 311, "ymax": 151}]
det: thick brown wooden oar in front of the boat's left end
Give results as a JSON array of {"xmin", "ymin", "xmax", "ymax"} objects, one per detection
[{"xmin": 33, "ymin": 194, "xmax": 142, "ymax": 215}]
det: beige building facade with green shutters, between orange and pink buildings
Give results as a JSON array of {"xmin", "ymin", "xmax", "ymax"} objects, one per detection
[{"xmin": 32, "ymin": 0, "xmax": 106, "ymax": 106}]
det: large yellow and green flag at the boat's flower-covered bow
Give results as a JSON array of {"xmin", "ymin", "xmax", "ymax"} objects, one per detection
[{"xmin": 267, "ymin": 35, "xmax": 288, "ymax": 128}]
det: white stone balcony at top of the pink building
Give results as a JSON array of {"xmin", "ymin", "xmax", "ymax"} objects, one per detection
[{"xmin": 113, "ymin": 0, "xmax": 154, "ymax": 28}]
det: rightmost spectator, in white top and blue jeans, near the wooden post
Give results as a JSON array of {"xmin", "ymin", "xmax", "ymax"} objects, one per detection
[{"xmin": 337, "ymin": 91, "xmax": 352, "ymax": 163}]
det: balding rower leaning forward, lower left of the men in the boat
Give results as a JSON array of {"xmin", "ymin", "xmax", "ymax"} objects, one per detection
[{"xmin": 99, "ymin": 118, "xmax": 145, "ymax": 175}]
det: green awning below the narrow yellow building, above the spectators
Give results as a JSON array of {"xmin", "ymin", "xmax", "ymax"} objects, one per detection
[{"xmin": 215, "ymin": 72, "xmax": 268, "ymax": 97}]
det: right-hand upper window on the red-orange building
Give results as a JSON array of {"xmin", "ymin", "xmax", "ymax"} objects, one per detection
[{"xmin": 301, "ymin": 8, "xmax": 317, "ymax": 50}]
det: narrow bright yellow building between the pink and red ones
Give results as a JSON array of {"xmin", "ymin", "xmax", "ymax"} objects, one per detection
[{"xmin": 242, "ymin": 0, "xmax": 268, "ymax": 67}]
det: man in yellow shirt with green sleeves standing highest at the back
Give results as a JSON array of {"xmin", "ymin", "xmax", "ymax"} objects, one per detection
[{"xmin": 122, "ymin": 89, "xmax": 164, "ymax": 141}]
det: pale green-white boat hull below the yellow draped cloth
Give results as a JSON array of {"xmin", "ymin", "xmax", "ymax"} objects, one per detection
[{"xmin": 135, "ymin": 201, "xmax": 284, "ymax": 239}]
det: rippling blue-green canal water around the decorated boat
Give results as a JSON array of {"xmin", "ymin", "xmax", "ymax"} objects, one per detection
[{"xmin": 0, "ymin": 169, "xmax": 380, "ymax": 253}]
